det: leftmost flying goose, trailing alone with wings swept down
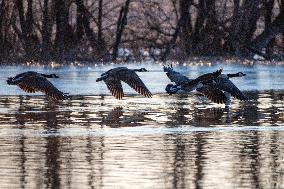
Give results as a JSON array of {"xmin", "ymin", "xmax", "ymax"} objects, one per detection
[{"xmin": 7, "ymin": 71, "xmax": 67, "ymax": 100}]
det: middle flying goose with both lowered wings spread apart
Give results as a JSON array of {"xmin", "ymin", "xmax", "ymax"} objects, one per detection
[{"xmin": 96, "ymin": 67, "xmax": 152, "ymax": 99}]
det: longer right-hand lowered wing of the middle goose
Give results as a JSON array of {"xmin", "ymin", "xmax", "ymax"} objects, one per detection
[{"xmin": 117, "ymin": 69, "xmax": 152, "ymax": 98}]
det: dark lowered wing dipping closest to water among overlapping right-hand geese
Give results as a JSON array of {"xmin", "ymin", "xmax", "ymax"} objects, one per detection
[{"xmin": 196, "ymin": 85, "xmax": 228, "ymax": 104}]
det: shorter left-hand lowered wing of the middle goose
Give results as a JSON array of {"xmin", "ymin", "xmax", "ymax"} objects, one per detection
[{"xmin": 105, "ymin": 77, "xmax": 124, "ymax": 100}]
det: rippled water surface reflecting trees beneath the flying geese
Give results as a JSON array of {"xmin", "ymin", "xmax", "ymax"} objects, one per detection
[{"xmin": 0, "ymin": 62, "xmax": 284, "ymax": 188}]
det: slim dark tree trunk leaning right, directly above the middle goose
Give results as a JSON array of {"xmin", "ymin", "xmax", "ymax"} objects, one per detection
[{"xmin": 112, "ymin": 0, "xmax": 130, "ymax": 61}]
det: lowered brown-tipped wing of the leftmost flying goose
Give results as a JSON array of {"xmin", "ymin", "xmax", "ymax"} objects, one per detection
[{"xmin": 18, "ymin": 76, "xmax": 66, "ymax": 100}]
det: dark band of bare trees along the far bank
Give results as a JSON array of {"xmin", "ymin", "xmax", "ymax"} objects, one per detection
[{"xmin": 0, "ymin": 0, "xmax": 284, "ymax": 61}]
